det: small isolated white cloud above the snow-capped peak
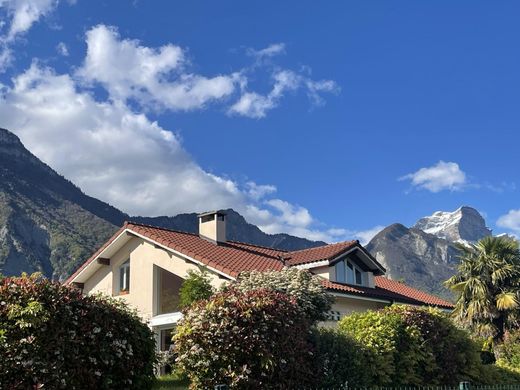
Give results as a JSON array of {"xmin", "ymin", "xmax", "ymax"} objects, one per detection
[{"xmin": 399, "ymin": 161, "xmax": 467, "ymax": 192}]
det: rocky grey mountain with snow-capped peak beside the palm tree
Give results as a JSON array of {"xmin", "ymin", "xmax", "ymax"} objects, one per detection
[{"xmin": 367, "ymin": 206, "xmax": 491, "ymax": 298}]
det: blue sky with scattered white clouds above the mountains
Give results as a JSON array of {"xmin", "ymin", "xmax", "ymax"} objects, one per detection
[{"xmin": 0, "ymin": 0, "xmax": 520, "ymax": 241}]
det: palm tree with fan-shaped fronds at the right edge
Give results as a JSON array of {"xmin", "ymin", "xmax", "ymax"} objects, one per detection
[{"xmin": 445, "ymin": 237, "xmax": 520, "ymax": 341}]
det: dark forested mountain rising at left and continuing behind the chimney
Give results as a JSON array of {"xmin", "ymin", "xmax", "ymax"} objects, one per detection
[{"xmin": 0, "ymin": 129, "xmax": 322, "ymax": 279}]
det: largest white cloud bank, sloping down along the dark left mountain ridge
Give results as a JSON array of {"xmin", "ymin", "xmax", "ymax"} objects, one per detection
[{"xmin": 0, "ymin": 63, "xmax": 351, "ymax": 242}]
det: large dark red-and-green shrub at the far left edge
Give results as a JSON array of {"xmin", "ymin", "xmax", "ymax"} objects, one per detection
[{"xmin": 0, "ymin": 276, "xmax": 155, "ymax": 389}]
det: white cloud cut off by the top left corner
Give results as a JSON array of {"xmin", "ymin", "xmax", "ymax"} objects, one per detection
[{"xmin": 0, "ymin": 0, "xmax": 58, "ymax": 71}]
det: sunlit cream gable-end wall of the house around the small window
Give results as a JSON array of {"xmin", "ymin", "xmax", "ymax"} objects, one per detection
[{"xmin": 83, "ymin": 237, "xmax": 224, "ymax": 321}]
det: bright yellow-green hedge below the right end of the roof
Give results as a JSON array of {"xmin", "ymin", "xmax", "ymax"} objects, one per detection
[{"xmin": 339, "ymin": 306, "xmax": 490, "ymax": 386}]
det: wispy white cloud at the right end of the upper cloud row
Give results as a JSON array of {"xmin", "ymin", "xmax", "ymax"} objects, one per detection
[{"xmin": 228, "ymin": 70, "xmax": 339, "ymax": 119}]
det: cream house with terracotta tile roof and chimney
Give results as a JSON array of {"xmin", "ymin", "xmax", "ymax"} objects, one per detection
[{"xmin": 65, "ymin": 211, "xmax": 452, "ymax": 350}]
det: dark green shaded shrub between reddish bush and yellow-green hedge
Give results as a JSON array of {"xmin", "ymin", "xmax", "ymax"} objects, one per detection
[{"xmin": 313, "ymin": 328, "xmax": 370, "ymax": 389}]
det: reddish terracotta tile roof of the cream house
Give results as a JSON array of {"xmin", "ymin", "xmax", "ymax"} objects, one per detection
[{"xmin": 65, "ymin": 222, "xmax": 453, "ymax": 308}]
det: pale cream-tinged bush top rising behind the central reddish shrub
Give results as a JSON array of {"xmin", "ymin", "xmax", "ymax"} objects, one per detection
[{"xmin": 234, "ymin": 268, "xmax": 334, "ymax": 322}]
